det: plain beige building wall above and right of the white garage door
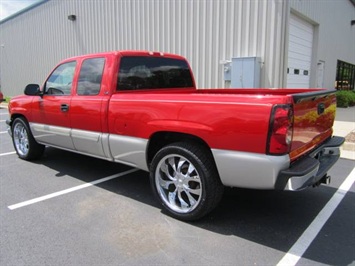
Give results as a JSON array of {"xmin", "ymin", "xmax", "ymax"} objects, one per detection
[{"xmin": 290, "ymin": 0, "xmax": 355, "ymax": 88}]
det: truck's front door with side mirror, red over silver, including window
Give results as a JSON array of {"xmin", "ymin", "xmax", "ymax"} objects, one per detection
[{"xmin": 31, "ymin": 61, "xmax": 76, "ymax": 149}]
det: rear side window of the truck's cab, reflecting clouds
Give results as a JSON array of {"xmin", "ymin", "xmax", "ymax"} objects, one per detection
[{"xmin": 77, "ymin": 58, "xmax": 105, "ymax": 95}]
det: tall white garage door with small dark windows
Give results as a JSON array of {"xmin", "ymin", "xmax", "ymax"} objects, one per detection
[{"xmin": 287, "ymin": 14, "xmax": 314, "ymax": 88}]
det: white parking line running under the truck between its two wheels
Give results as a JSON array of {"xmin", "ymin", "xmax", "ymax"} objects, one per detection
[{"xmin": 8, "ymin": 169, "xmax": 138, "ymax": 210}]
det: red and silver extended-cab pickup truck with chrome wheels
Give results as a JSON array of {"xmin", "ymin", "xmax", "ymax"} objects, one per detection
[{"xmin": 7, "ymin": 51, "xmax": 344, "ymax": 220}]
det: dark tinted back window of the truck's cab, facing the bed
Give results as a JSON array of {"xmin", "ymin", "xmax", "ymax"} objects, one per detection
[{"xmin": 117, "ymin": 56, "xmax": 194, "ymax": 90}]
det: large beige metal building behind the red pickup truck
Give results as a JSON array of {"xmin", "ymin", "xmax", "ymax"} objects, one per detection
[{"xmin": 0, "ymin": 0, "xmax": 355, "ymax": 96}]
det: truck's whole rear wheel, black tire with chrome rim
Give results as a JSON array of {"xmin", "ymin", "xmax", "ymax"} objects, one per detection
[{"xmin": 150, "ymin": 142, "xmax": 224, "ymax": 221}]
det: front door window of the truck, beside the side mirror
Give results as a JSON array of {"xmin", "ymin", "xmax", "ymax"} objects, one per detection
[{"xmin": 45, "ymin": 61, "xmax": 76, "ymax": 95}]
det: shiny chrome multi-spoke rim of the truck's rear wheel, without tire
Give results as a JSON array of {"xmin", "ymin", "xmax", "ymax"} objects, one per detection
[{"xmin": 155, "ymin": 154, "xmax": 202, "ymax": 213}]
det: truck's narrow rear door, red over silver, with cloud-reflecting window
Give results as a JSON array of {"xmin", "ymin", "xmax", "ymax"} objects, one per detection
[{"xmin": 70, "ymin": 57, "xmax": 110, "ymax": 158}]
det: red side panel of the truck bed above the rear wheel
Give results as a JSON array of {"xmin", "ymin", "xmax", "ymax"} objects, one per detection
[{"xmin": 109, "ymin": 91, "xmax": 278, "ymax": 153}]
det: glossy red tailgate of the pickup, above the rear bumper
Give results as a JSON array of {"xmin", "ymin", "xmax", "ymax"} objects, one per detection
[{"xmin": 290, "ymin": 90, "xmax": 336, "ymax": 161}]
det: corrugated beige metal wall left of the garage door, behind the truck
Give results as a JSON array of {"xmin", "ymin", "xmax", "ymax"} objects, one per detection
[{"xmin": 0, "ymin": 0, "xmax": 288, "ymax": 96}]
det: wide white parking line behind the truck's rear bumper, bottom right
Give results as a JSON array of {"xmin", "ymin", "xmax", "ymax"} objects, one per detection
[{"xmin": 277, "ymin": 168, "xmax": 355, "ymax": 266}]
